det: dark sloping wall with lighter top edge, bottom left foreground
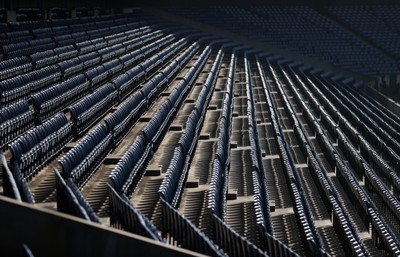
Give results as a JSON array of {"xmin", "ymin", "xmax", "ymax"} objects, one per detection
[{"xmin": 0, "ymin": 196, "xmax": 206, "ymax": 257}]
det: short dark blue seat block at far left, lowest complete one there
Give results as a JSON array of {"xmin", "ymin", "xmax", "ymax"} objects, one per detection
[{"xmin": 9, "ymin": 113, "xmax": 72, "ymax": 179}]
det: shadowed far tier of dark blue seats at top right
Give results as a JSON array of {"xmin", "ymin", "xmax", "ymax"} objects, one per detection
[{"xmin": 165, "ymin": 5, "xmax": 400, "ymax": 75}]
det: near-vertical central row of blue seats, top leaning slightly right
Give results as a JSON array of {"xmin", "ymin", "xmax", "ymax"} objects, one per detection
[{"xmin": 207, "ymin": 51, "xmax": 236, "ymax": 220}]
